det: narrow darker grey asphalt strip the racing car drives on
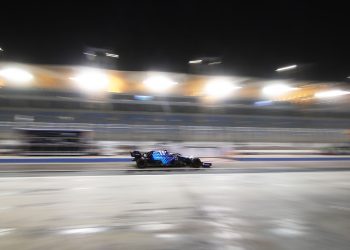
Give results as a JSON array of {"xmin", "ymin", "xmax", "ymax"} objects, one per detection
[{"xmin": 0, "ymin": 160, "xmax": 350, "ymax": 178}]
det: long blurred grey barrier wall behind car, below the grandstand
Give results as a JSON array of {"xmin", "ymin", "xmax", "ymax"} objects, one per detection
[{"xmin": 0, "ymin": 122, "xmax": 349, "ymax": 143}]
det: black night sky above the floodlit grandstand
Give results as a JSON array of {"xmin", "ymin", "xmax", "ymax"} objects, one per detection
[{"xmin": 0, "ymin": 0, "xmax": 350, "ymax": 81}]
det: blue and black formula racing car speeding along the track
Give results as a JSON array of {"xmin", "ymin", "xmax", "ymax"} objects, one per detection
[{"xmin": 130, "ymin": 150, "xmax": 212, "ymax": 168}]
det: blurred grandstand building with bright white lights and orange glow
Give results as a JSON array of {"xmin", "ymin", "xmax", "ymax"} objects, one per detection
[{"xmin": 0, "ymin": 62, "xmax": 350, "ymax": 144}]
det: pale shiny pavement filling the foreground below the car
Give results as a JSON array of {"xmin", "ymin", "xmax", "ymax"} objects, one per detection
[{"xmin": 0, "ymin": 168, "xmax": 350, "ymax": 250}]
